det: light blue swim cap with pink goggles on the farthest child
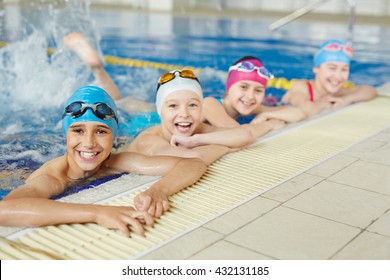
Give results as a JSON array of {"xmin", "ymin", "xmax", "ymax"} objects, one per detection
[{"xmin": 313, "ymin": 39, "xmax": 353, "ymax": 67}]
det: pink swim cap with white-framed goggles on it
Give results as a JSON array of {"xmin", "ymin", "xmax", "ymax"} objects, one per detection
[{"xmin": 226, "ymin": 58, "xmax": 272, "ymax": 91}]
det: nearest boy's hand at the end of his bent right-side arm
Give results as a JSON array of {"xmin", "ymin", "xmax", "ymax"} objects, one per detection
[{"xmin": 134, "ymin": 187, "xmax": 169, "ymax": 218}]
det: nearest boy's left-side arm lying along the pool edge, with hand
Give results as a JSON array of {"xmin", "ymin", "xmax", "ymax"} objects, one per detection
[{"xmin": 0, "ymin": 174, "xmax": 153, "ymax": 236}]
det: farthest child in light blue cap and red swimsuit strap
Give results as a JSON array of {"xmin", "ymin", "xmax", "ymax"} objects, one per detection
[{"xmin": 282, "ymin": 39, "xmax": 377, "ymax": 116}]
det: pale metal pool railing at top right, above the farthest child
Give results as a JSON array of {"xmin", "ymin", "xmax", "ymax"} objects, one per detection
[{"xmin": 269, "ymin": 0, "xmax": 356, "ymax": 46}]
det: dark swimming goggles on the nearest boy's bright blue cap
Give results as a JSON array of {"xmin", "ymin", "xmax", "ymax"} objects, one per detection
[{"xmin": 62, "ymin": 101, "xmax": 118, "ymax": 123}]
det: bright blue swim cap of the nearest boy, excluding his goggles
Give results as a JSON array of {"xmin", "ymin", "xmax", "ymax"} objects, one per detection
[{"xmin": 62, "ymin": 86, "xmax": 118, "ymax": 136}]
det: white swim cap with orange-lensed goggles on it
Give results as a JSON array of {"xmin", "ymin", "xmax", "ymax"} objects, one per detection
[{"xmin": 156, "ymin": 70, "xmax": 203, "ymax": 115}]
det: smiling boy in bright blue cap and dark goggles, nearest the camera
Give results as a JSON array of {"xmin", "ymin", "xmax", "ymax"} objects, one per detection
[{"xmin": 0, "ymin": 86, "xmax": 206, "ymax": 236}]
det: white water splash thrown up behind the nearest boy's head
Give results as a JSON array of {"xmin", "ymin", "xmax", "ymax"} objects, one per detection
[{"xmin": 0, "ymin": 1, "xmax": 99, "ymax": 133}]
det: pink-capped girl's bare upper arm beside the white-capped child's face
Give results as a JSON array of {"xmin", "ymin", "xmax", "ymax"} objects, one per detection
[{"xmin": 202, "ymin": 97, "xmax": 240, "ymax": 128}]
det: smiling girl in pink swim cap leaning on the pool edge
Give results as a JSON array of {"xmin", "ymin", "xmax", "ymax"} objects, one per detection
[{"xmin": 203, "ymin": 56, "xmax": 306, "ymax": 127}]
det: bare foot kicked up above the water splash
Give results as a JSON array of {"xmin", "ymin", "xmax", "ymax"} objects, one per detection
[{"xmin": 64, "ymin": 32, "xmax": 103, "ymax": 68}]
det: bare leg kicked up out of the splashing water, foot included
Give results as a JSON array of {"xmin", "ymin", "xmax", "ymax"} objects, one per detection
[{"xmin": 63, "ymin": 32, "xmax": 155, "ymax": 113}]
